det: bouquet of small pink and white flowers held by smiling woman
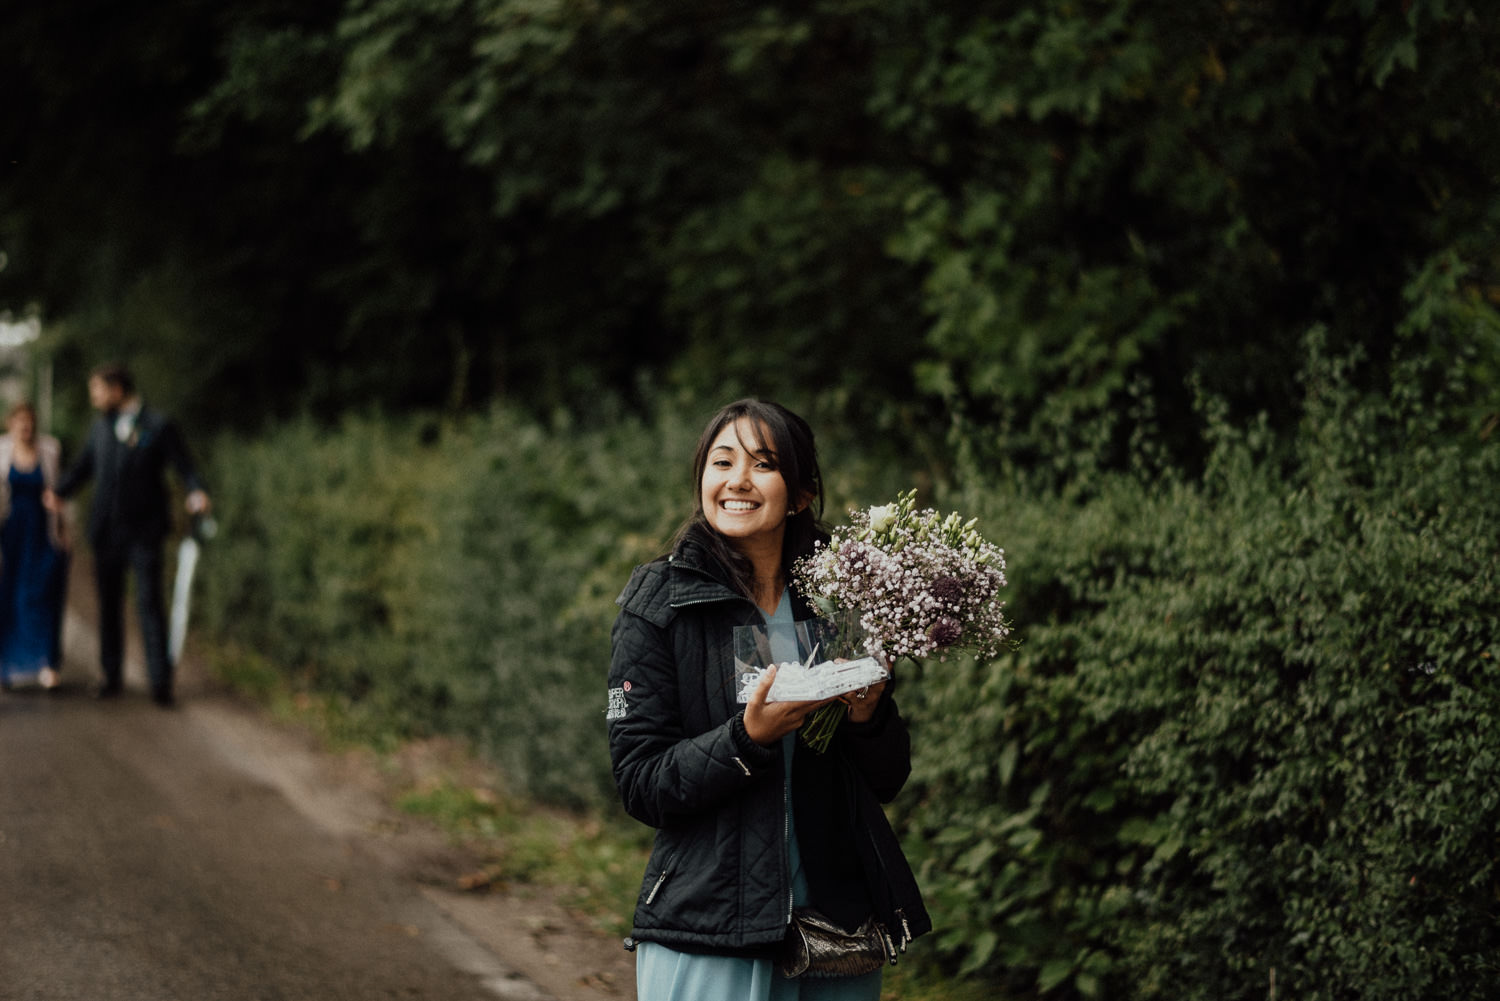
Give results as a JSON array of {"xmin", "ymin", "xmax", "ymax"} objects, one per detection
[{"xmin": 792, "ymin": 491, "xmax": 1011, "ymax": 750}]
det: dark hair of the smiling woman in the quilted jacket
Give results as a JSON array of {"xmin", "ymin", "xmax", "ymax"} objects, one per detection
[{"xmin": 672, "ymin": 399, "xmax": 828, "ymax": 594}]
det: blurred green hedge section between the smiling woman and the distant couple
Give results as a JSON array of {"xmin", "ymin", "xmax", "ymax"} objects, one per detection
[{"xmin": 203, "ymin": 411, "xmax": 692, "ymax": 804}]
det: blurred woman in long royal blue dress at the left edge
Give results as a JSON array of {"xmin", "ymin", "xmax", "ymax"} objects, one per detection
[{"xmin": 0, "ymin": 402, "xmax": 68, "ymax": 689}]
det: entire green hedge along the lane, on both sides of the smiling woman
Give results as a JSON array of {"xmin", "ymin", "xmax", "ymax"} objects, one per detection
[{"xmin": 193, "ymin": 360, "xmax": 1500, "ymax": 999}]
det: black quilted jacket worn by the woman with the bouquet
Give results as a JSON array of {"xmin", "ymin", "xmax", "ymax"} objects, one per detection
[{"xmin": 608, "ymin": 525, "xmax": 932, "ymax": 954}]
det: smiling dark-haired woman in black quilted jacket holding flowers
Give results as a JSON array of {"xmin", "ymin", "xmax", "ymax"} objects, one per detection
[{"xmin": 606, "ymin": 399, "xmax": 932, "ymax": 1001}]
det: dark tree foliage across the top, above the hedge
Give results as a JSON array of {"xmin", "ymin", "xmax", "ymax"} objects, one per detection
[{"xmin": 0, "ymin": 0, "xmax": 1500, "ymax": 459}]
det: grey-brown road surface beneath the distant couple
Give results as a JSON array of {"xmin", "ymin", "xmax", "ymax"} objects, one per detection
[{"xmin": 0, "ymin": 567, "xmax": 633, "ymax": 1001}]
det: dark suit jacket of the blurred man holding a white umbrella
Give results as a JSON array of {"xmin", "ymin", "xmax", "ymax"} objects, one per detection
[{"xmin": 54, "ymin": 407, "xmax": 203, "ymax": 546}]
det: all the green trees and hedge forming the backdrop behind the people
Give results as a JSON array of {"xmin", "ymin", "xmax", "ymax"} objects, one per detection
[{"xmin": 0, "ymin": 0, "xmax": 1500, "ymax": 999}]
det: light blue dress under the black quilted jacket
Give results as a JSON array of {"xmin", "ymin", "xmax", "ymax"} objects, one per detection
[{"xmin": 636, "ymin": 591, "xmax": 881, "ymax": 1001}]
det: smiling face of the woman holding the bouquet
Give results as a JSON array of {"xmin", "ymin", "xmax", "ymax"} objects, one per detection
[{"xmin": 699, "ymin": 419, "xmax": 791, "ymax": 543}]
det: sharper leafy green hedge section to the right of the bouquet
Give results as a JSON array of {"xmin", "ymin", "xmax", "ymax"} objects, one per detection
[{"xmin": 902, "ymin": 340, "xmax": 1500, "ymax": 999}]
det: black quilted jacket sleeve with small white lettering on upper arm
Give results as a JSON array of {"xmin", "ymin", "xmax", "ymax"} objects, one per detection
[{"xmin": 609, "ymin": 579, "xmax": 782, "ymax": 827}]
